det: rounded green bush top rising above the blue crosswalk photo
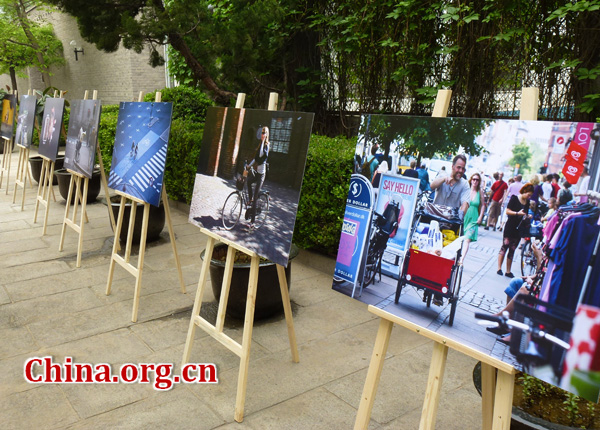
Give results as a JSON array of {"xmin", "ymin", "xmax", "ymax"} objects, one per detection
[{"xmin": 144, "ymin": 86, "xmax": 214, "ymax": 124}]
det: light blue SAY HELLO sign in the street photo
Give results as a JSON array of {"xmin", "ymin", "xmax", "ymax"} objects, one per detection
[{"xmin": 375, "ymin": 173, "xmax": 419, "ymax": 279}]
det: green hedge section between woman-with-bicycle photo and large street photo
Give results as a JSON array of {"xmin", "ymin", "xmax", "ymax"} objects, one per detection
[{"xmin": 293, "ymin": 135, "xmax": 356, "ymax": 255}]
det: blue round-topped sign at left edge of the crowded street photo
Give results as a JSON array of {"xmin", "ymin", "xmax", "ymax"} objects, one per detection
[{"xmin": 335, "ymin": 174, "xmax": 373, "ymax": 285}]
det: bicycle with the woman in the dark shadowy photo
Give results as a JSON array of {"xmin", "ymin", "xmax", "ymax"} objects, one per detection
[{"xmin": 221, "ymin": 164, "xmax": 270, "ymax": 230}]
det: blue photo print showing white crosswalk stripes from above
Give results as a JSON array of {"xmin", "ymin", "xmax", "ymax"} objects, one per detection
[{"xmin": 108, "ymin": 102, "xmax": 173, "ymax": 206}]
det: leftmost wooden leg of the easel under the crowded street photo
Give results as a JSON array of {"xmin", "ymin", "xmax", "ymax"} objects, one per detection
[{"xmin": 354, "ymin": 318, "xmax": 394, "ymax": 430}]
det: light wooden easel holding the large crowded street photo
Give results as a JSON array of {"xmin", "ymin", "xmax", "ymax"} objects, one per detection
[{"xmin": 354, "ymin": 88, "xmax": 539, "ymax": 430}]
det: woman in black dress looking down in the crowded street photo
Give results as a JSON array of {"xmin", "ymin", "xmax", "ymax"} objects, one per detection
[{"xmin": 497, "ymin": 184, "xmax": 533, "ymax": 278}]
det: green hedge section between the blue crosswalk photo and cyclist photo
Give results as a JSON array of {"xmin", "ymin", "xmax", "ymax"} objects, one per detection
[{"xmin": 165, "ymin": 118, "xmax": 204, "ymax": 203}]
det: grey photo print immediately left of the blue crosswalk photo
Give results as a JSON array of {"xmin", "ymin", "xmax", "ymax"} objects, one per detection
[{"xmin": 64, "ymin": 100, "xmax": 102, "ymax": 178}]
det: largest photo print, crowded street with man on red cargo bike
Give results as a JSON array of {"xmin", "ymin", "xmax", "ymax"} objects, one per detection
[{"xmin": 332, "ymin": 115, "xmax": 600, "ymax": 402}]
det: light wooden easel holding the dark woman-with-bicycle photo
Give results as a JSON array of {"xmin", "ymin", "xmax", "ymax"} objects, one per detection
[{"xmin": 182, "ymin": 93, "xmax": 300, "ymax": 422}]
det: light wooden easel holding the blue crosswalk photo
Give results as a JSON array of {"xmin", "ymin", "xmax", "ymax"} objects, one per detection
[{"xmin": 106, "ymin": 91, "xmax": 185, "ymax": 322}]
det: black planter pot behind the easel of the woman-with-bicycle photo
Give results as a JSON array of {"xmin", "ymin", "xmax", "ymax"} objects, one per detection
[{"xmin": 200, "ymin": 244, "xmax": 298, "ymax": 320}]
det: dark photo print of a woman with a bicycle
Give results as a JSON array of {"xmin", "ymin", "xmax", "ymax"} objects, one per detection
[{"xmin": 189, "ymin": 107, "xmax": 314, "ymax": 266}]
